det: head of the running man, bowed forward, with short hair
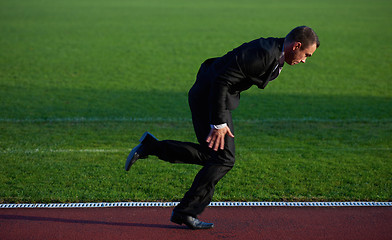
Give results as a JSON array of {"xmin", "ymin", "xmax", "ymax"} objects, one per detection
[{"xmin": 284, "ymin": 26, "xmax": 320, "ymax": 65}]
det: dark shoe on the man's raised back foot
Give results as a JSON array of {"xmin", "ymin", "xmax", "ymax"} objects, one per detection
[{"xmin": 125, "ymin": 132, "xmax": 158, "ymax": 171}]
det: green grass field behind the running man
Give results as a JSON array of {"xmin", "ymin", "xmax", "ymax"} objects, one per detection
[{"xmin": 0, "ymin": 0, "xmax": 392, "ymax": 203}]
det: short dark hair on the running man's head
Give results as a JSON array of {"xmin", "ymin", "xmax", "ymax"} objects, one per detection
[{"xmin": 285, "ymin": 26, "xmax": 320, "ymax": 49}]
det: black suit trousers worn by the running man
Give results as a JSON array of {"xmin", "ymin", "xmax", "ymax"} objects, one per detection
[{"xmin": 153, "ymin": 87, "xmax": 235, "ymax": 217}]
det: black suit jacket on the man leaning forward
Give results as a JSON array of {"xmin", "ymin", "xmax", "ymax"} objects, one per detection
[{"xmin": 189, "ymin": 38, "xmax": 284, "ymax": 124}]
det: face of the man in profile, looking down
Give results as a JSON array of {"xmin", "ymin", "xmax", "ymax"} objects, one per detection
[{"xmin": 284, "ymin": 42, "xmax": 317, "ymax": 65}]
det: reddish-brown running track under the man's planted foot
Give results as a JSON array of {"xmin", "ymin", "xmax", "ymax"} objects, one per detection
[{"xmin": 0, "ymin": 207, "xmax": 392, "ymax": 240}]
